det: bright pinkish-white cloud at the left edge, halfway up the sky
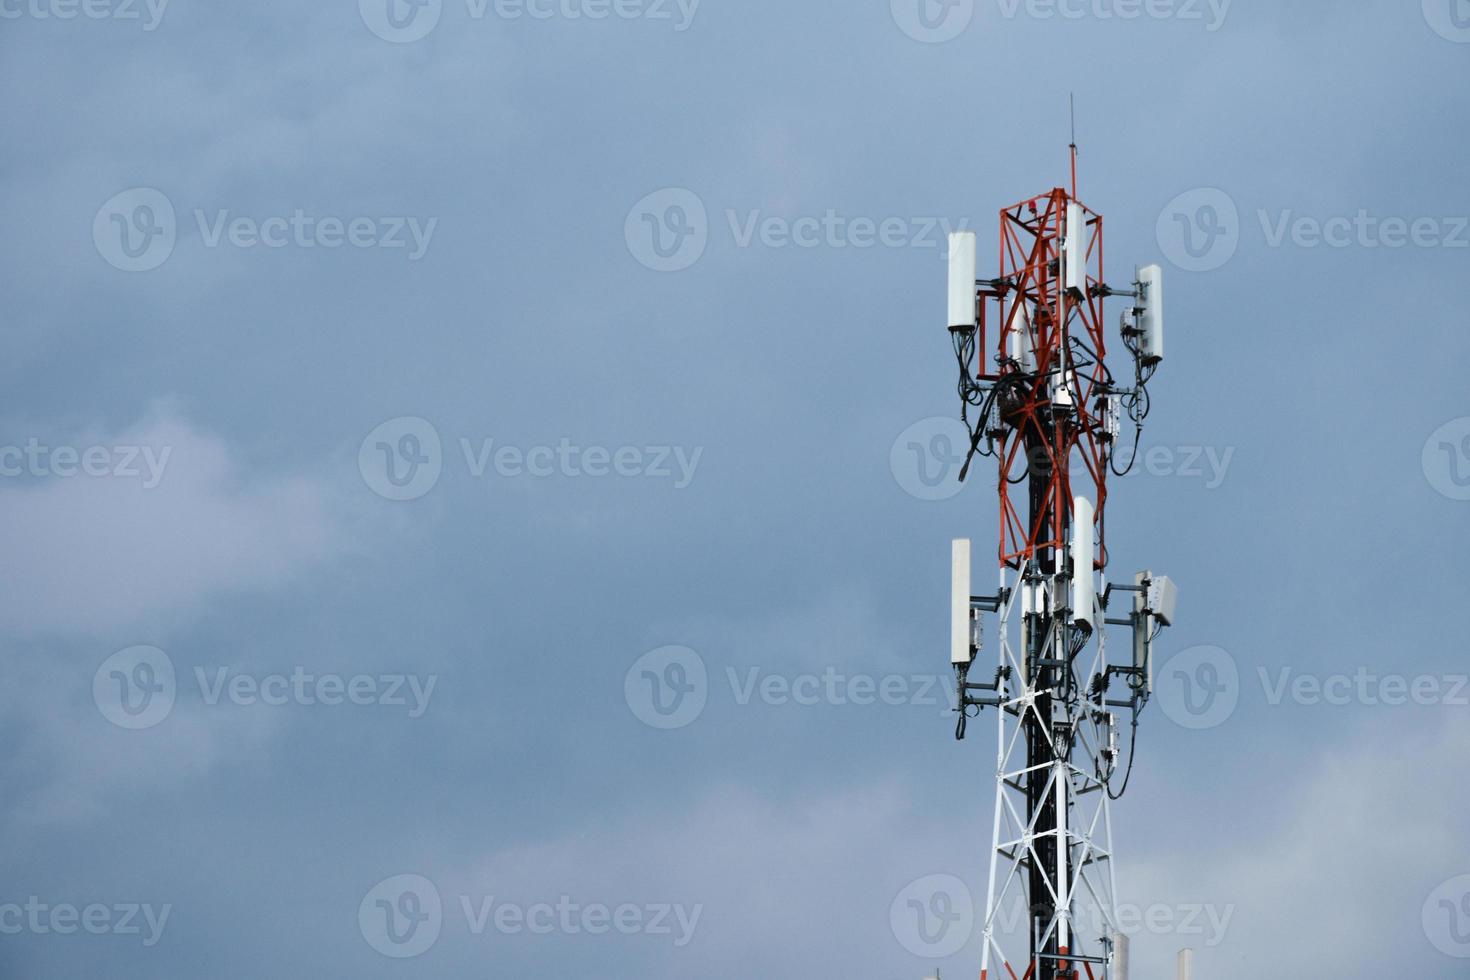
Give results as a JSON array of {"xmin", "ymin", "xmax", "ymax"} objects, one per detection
[{"xmin": 0, "ymin": 411, "xmax": 343, "ymax": 645}]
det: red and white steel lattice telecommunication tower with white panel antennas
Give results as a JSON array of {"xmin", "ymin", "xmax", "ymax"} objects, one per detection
[{"xmin": 948, "ymin": 143, "xmax": 1176, "ymax": 980}]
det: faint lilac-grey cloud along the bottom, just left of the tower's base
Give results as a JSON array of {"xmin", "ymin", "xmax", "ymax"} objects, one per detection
[{"xmin": 438, "ymin": 783, "xmax": 938, "ymax": 977}]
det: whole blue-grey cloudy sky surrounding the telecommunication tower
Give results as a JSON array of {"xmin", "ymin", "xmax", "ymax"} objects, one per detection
[{"xmin": 0, "ymin": 0, "xmax": 1470, "ymax": 980}]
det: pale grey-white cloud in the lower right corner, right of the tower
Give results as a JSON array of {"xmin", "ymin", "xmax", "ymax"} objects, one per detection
[{"xmin": 1125, "ymin": 713, "xmax": 1470, "ymax": 980}]
